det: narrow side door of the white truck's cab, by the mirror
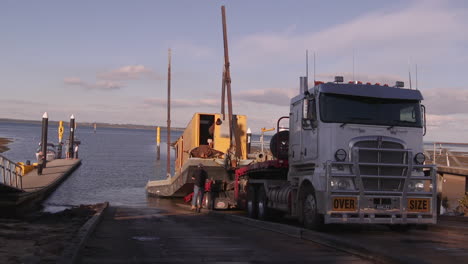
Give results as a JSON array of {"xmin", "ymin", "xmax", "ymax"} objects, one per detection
[{"xmin": 301, "ymin": 96, "xmax": 318, "ymax": 162}]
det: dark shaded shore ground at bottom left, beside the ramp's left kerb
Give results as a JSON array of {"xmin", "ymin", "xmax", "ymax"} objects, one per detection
[{"xmin": 0, "ymin": 204, "xmax": 102, "ymax": 263}]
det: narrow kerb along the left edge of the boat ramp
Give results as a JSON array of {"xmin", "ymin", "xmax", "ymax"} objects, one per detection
[{"xmin": 57, "ymin": 202, "xmax": 109, "ymax": 263}]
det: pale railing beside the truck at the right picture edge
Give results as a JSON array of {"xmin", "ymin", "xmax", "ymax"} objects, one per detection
[{"xmin": 425, "ymin": 142, "xmax": 468, "ymax": 168}]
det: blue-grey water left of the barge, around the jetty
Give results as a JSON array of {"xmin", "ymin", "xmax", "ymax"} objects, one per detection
[{"xmin": 0, "ymin": 122, "xmax": 181, "ymax": 211}]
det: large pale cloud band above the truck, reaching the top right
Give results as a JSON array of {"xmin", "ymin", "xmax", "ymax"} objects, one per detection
[{"xmin": 234, "ymin": 1, "xmax": 468, "ymax": 65}]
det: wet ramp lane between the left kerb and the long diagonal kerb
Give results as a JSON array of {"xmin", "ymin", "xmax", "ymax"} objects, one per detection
[{"xmin": 80, "ymin": 200, "xmax": 370, "ymax": 263}]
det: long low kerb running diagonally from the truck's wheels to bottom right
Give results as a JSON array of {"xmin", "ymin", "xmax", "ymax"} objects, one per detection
[{"xmin": 209, "ymin": 211, "xmax": 421, "ymax": 263}]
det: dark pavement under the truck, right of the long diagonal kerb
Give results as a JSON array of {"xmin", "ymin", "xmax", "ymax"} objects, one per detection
[{"xmin": 213, "ymin": 211, "xmax": 468, "ymax": 263}]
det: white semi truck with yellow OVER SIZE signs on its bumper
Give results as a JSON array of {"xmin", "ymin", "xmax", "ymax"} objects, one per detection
[{"xmin": 236, "ymin": 76, "xmax": 437, "ymax": 229}]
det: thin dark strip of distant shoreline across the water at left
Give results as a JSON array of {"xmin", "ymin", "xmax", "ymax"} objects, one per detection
[{"xmin": 0, "ymin": 118, "xmax": 184, "ymax": 131}]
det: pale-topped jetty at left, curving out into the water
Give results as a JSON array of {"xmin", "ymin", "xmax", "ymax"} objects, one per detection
[{"xmin": 0, "ymin": 159, "xmax": 81, "ymax": 214}]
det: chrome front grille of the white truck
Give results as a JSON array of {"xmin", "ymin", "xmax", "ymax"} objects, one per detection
[{"xmin": 353, "ymin": 138, "xmax": 408, "ymax": 192}]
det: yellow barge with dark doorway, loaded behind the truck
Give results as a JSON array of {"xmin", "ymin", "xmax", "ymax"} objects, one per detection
[{"xmin": 146, "ymin": 113, "xmax": 252, "ymax": 202}]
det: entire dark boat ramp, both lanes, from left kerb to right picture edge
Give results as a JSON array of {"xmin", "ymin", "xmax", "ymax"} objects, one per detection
[{"xmin": 73, "ymin": 200, "xmax": 468, "ymax": 263}]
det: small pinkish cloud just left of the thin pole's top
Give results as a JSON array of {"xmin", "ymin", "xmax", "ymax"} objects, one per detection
[{"xmin": 97, "ymin": 65, "xmax": 164, "ymax": 81}]
